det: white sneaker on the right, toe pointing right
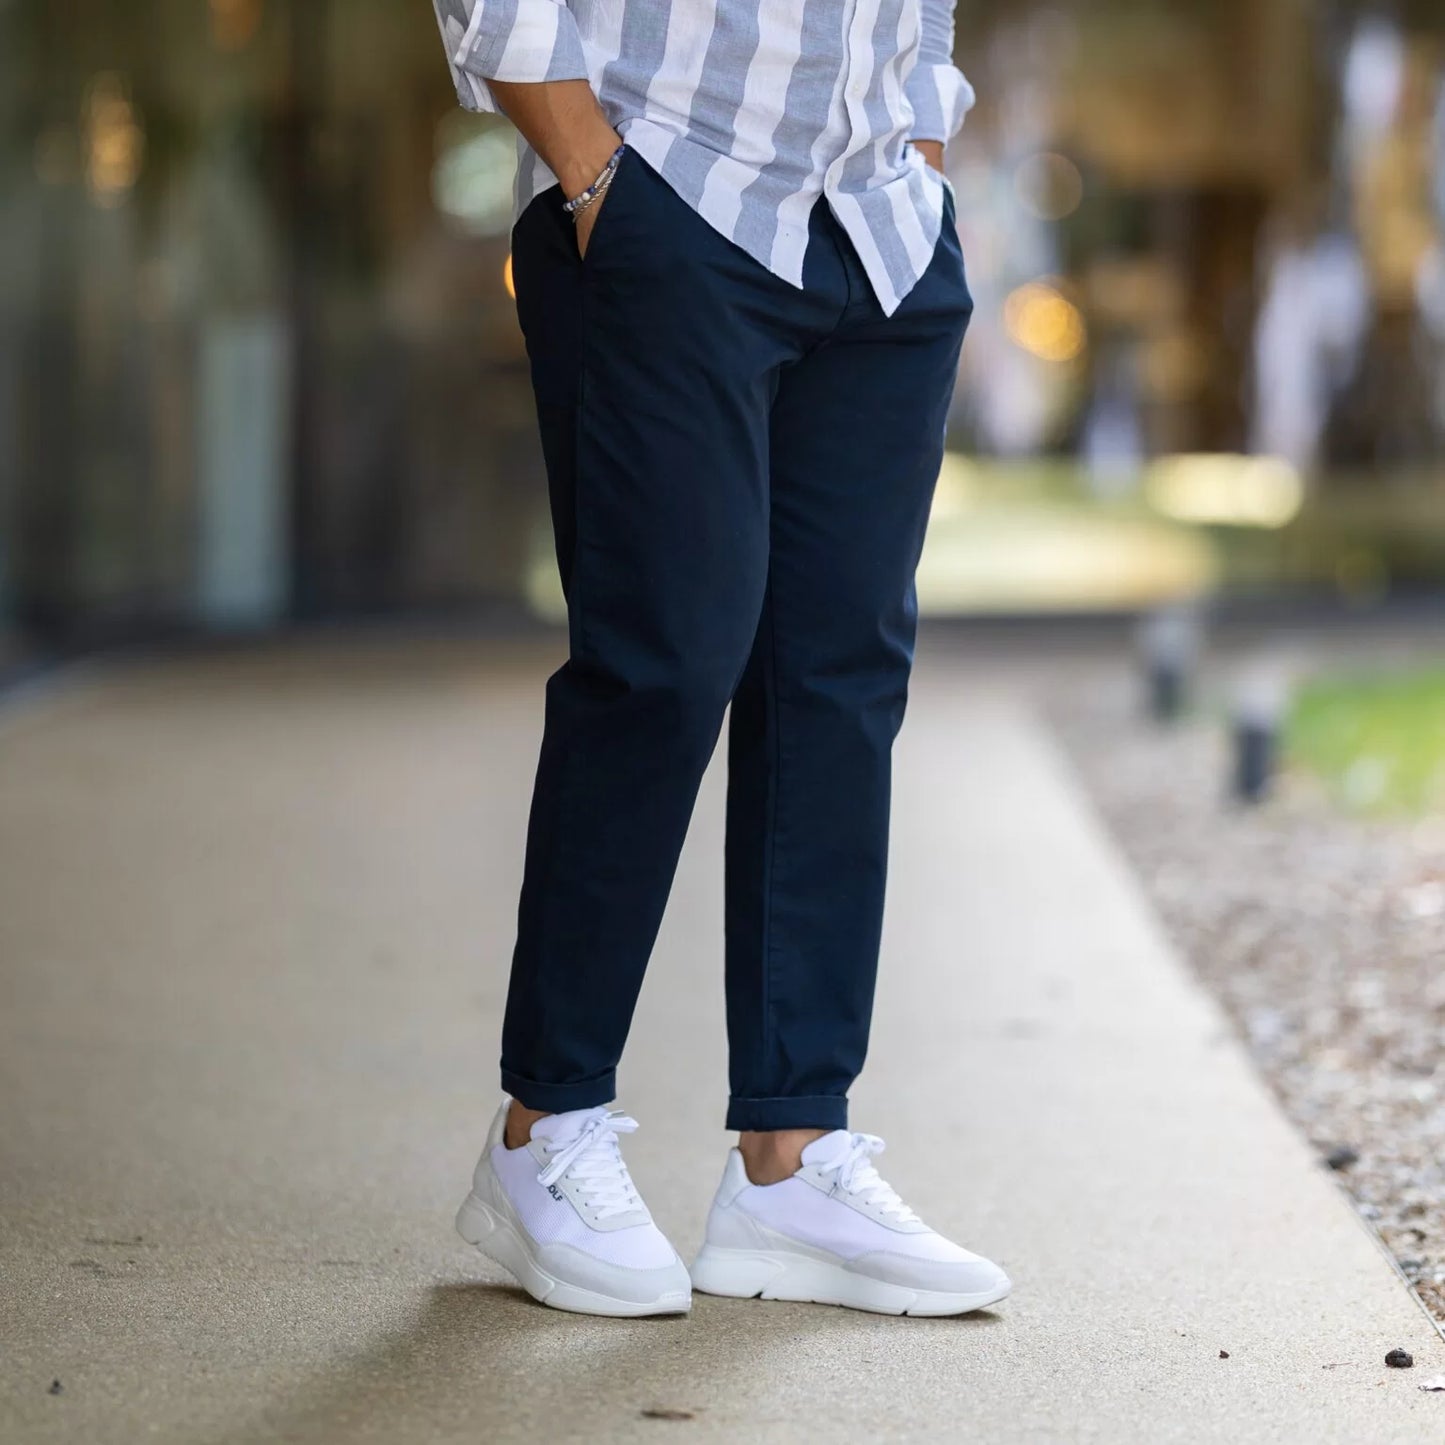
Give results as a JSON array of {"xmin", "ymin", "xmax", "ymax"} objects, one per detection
[{"xmin": 692, "ymin": 1129, "xmax": 1010, "ymax": 1315}]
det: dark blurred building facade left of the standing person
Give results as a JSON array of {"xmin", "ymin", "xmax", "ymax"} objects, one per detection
[{"xmin": 0, "ymin": 0, "xmax": 536, "ymax": 661}]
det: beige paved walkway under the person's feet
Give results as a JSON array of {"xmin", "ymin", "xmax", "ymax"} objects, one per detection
[{"xmin": 0, "ymin": 644, "xmax": 1445, "ymax": 1445}]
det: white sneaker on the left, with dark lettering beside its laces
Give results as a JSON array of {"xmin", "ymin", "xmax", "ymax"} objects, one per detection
[{"xmin": 457, "ymin": 1100, "xmax": 692, "ymax": 1315}]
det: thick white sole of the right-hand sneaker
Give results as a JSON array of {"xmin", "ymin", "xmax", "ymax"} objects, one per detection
[{"xmin": 692, "ymin": 1244, "xmax": 1012, "ymax": 1316}]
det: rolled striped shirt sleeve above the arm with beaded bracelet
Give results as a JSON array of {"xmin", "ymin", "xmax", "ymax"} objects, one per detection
[{"xmin": 434, "ymin": 0, "xmax": 588, "ymax": 111}]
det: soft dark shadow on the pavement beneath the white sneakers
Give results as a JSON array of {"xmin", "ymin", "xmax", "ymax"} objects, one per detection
[{"xmin": 206, "ymin": 1283, "xmax": 1003, "ymax": 1445}]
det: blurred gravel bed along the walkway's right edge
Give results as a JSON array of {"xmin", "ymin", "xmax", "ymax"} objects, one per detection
[{"xmin": 1046, "ymin": 678, "xmax": 1445, "ymax": 1325}]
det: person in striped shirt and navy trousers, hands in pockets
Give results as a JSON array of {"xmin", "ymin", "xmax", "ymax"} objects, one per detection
[{"xmin": 435, "ymin": 0, "xmax": 1009, "ymax": 1315}]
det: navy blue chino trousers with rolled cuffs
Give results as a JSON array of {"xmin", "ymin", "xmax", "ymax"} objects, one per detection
[{"xmin": 501, "ymin": 150, "xmax": 972, "ymax": 1129}]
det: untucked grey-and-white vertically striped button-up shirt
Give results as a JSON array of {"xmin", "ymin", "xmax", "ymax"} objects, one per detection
[{"xmin": 434, "ymin": 0, "xmax": 974, "ymax": 312}]
